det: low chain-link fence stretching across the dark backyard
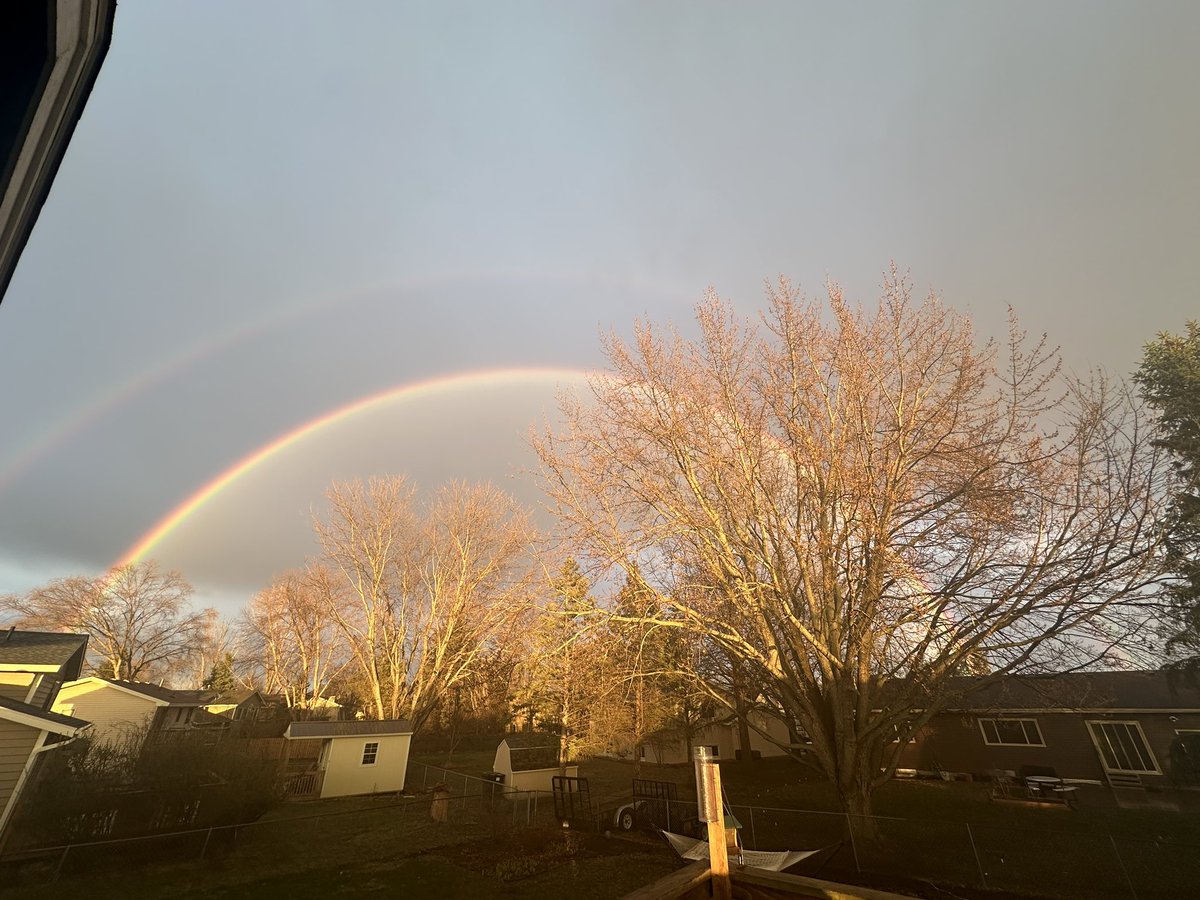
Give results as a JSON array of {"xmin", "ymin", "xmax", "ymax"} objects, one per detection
[{"xmin": 0, "ymin": 763, "xmax": 1200, "ymax": 900}]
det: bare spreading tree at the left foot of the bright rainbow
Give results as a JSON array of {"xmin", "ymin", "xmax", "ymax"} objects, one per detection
[{"xmin": 0, "ymin": 562, "xmax": 216, "ymax": 679}]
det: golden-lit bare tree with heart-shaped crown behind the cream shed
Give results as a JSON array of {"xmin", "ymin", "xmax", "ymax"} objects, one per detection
[{"xmin": 317, "ymin": 476, "xmax": 530, "ymax": 728}]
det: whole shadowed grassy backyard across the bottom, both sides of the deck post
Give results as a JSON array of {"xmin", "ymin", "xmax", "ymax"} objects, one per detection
[{"xmin": 0, "ymin": 750, "xmax": 1200, "ymax": 900}]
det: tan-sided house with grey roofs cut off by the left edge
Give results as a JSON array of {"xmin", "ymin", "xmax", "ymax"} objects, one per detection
[{"xmin": 0, "ymin": 628, "xmax": 90, "ymax": 846}]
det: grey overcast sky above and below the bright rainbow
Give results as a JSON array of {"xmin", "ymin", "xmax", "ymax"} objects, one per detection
[{"xmin": 0, "ymin": 0, "xmax": 1200, "ymax": 610}]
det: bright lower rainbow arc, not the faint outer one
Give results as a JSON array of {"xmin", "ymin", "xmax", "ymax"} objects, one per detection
[{"xmin": 114, "ymin": 367, "xmax": 589, "ymax": 566}]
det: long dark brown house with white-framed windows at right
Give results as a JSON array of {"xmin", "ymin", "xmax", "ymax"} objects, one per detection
[{"xmin": 900, "ymin": 671, "xmax": 1200, "ymax": 787}]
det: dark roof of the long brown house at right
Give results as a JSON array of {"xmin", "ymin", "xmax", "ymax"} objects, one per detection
[{"xmin": 926, "ymin": 671, "xmax": 1200, "ymax": 712}]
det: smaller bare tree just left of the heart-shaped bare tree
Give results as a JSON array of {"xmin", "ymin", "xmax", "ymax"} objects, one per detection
[{"xmin": 242, "ymin": 565, "xmax": 348, "ymax": 709}]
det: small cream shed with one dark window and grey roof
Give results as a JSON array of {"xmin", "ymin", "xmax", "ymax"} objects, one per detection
[{"xmin": 283, "ymin": 719, "xmax": 413, "ymax": 799}]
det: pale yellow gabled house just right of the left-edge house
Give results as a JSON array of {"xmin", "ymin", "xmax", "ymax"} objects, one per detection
[{"xmin": 53, "ymin": 676, "xmax": 228, "ymax": 744}]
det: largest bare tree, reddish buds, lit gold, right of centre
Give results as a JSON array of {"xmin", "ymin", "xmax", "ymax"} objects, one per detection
[{"xmin": 535, "ymin": 269, "xmax": 1162, "ymax": 814}]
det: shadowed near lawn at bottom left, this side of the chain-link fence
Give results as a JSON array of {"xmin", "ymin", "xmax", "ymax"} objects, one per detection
[{"xmin": 0, "ymin": 798, "xmax": 679, "ymax": 900}]
